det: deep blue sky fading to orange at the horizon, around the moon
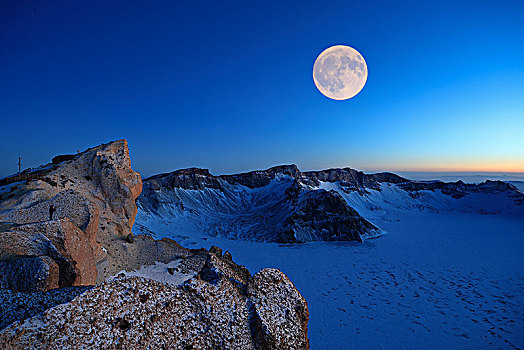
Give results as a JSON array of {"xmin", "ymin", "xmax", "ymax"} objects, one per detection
[{"xmin": 0, "ymin": 0, "xmax": 524, "ymax": 176}]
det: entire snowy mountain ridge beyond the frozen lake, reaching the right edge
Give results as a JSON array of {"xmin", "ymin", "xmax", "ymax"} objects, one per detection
[{"xmin": 135, "ymin": 165, "xmax": 524, "ymax": 243}]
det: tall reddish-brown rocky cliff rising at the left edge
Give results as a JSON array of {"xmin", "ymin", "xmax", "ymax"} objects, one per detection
[{"xmin": 0, "ymin": 140, "xmax": 142, "ymax": 291}]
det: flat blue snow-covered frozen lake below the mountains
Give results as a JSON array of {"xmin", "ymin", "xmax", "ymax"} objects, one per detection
[{"xmin": 139, "ymin": 210, "xmax": 524, "ymax": 349}]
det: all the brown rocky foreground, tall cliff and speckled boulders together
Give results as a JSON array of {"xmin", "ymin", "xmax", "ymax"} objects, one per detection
[{"xmin": 0, "ymin": 140, "xmax": 309, "ymax": 349}]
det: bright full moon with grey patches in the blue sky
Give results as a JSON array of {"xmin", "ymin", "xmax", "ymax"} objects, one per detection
[{"xmin": 313, "ymin": 45, "xmax": 368, "ymax": 100}]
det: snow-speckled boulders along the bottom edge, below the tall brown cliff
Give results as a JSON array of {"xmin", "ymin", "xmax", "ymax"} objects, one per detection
[{"xmin": 0, "ymin": 250, "xmax": 309, "ymax": 350}]
